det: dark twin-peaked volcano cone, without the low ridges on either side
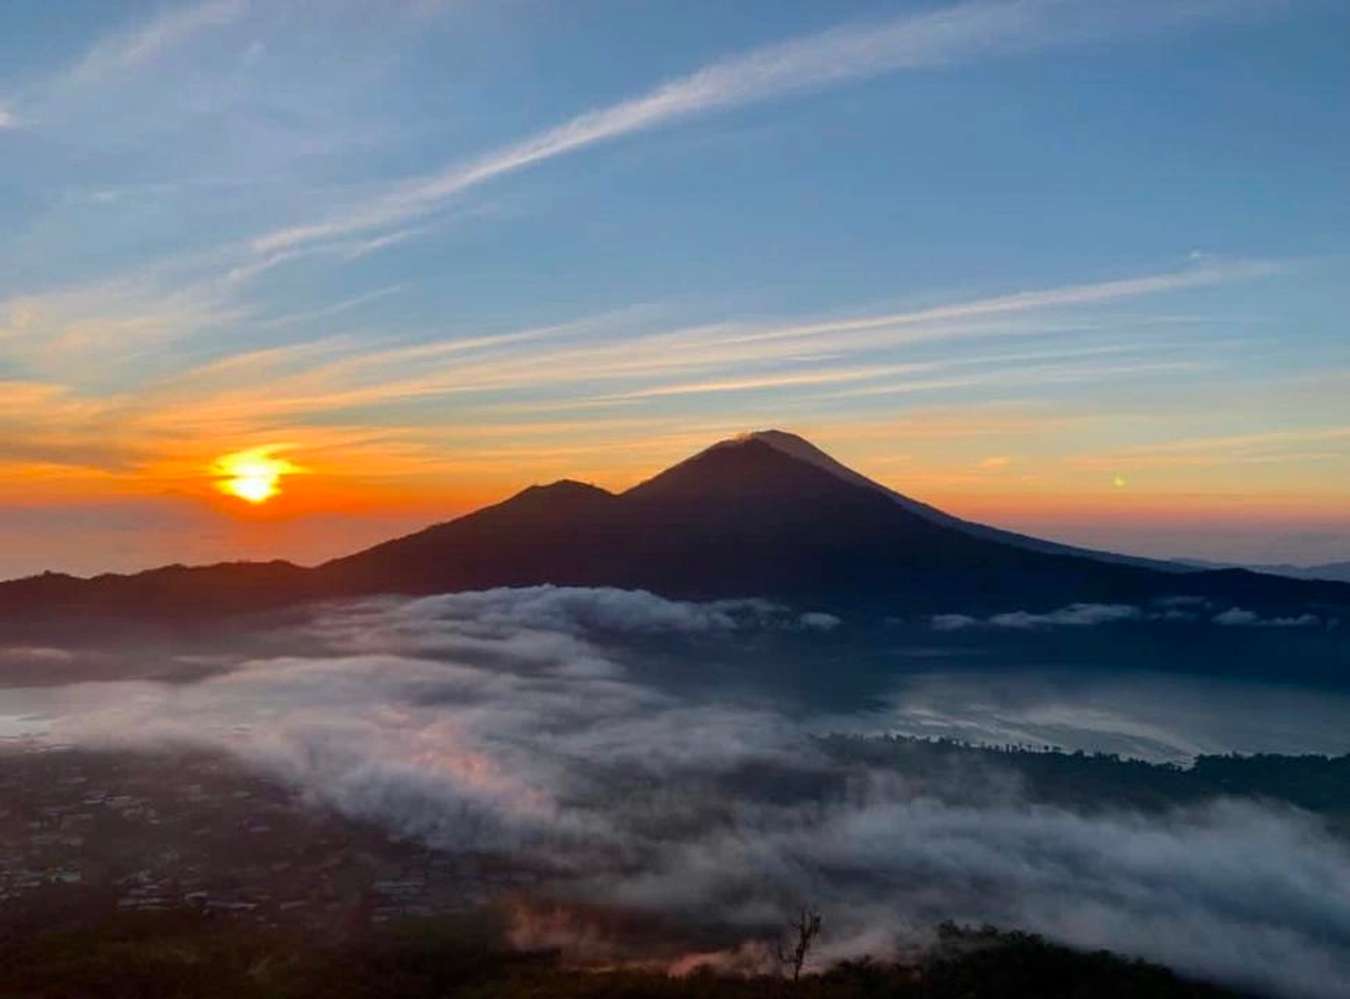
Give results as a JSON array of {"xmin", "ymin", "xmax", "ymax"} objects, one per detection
[{"xmin": 316, "ymin": 437, "xmax": 1150, "ymax": 608}]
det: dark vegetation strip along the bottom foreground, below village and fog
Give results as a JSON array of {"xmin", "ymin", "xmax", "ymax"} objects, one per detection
[{"xmin": 0, "ymin": 913, "xmax": 1231, "ymax": 999}]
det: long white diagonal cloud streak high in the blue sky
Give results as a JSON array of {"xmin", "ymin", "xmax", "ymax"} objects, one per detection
[{"xmin": 255, "ymin": 0, "xmax": 1274, "ymax": 254}]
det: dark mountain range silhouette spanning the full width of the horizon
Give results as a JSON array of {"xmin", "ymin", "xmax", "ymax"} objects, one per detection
[{"xmin": 0, "ymin": 431, "xmax": 1350, "ymax": 622}]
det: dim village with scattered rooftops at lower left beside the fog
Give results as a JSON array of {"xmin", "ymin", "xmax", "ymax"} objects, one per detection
[{"xmin": 0, "ymin": 743, "xmax": 515, "ymax": 933}]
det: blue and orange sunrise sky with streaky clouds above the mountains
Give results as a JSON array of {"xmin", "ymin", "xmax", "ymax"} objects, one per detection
[{"xmin": 0, "ymin": 0, "xmax": 1350, "ymax": 576}]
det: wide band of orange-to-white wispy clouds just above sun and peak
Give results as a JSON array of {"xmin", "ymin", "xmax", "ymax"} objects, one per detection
[{"xmin": 0, "ymin": 257, "xmax": 1269, "ymax": 496}]
